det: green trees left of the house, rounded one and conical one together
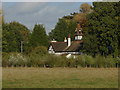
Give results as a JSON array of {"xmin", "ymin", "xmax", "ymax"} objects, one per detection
[{"xmin": 2, "ymin": 22, "xmax": 48, "ymax": 53}]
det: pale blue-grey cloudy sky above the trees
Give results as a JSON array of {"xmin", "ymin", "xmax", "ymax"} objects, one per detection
[{"xmin": 2, "ymin": 2, "xmax": 92, "ymax": 33}]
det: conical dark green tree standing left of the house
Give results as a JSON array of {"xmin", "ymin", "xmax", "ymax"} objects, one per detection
[{"xmin": 29, "ymin": 24, "xmax": 48, "ymax": 48}]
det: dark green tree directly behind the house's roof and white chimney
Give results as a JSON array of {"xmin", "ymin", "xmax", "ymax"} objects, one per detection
[{"xmin": 49, "ymin": 19, "xmax": 76, "ymax": 41}]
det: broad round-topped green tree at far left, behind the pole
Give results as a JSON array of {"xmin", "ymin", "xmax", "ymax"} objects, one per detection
[{"xmin": 2, "ymin": 22, "xmax": 29, "ymax": 52}]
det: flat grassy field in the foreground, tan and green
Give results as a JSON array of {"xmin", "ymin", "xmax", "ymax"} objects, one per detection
[{"xmin": 2, "ymin": 68, "xmax": 118, "ymax": 88}]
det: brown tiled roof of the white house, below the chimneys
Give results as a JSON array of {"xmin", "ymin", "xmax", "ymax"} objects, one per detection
[{"xmin": 51, "ymin": 40, "xmax": 83, "ymax": 52}]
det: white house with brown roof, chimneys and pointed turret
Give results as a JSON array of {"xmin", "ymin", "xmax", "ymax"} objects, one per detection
[{"xmin": 48, "ymin": 23, "xmax": 83, "ymax": 55}]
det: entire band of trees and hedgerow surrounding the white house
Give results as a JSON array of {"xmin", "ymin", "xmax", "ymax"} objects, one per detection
[{"xmin": 2, "ymin": 2, "xmax": 120, "ymax": 67}]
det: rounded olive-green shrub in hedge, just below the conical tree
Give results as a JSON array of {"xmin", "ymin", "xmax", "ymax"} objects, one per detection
[{"xmin": 27, "ymin": 46, "xmax": 48, "ymax": 67}]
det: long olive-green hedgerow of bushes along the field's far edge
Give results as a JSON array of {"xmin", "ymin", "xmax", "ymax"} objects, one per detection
[{"xmin": 2, "ymin": 50, "xmax": 120, "ymax": 68}]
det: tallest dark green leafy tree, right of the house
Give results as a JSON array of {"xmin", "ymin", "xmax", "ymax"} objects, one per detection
[{"xmin": 84, "ymin": 2, "xmax": 120, "ymax": 56}]
